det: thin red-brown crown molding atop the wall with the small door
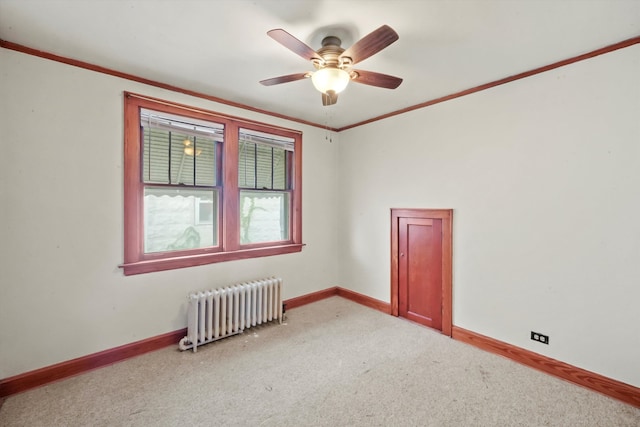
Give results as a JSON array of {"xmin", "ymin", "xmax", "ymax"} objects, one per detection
[{"xmin": 336, "ymin": 36, "xmax": 640, "ymax": 132}]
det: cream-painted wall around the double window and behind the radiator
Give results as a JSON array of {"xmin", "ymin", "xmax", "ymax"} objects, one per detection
[{"xmin": 0, "ymin": 49, "xmax": 338, "ymax": 378}]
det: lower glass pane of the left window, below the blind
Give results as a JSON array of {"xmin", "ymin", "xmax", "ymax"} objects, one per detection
[{"xmin": 144, "ymin": 187, "xmax": 218, "ymax": 253}]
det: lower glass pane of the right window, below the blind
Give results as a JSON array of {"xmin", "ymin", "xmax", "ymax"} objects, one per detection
[{"xmin": 240, "ymin": 190, "xmax": 291, "ymax": 244}]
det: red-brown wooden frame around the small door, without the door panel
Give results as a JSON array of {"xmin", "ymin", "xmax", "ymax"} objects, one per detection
[{"xmin": 391, "ymin": 208, "xmax": 453, "ymax": 336}]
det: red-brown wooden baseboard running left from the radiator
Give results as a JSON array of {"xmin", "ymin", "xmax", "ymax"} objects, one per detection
[{"xmin": 0, "ymin": 329, "xmax": 187, "ymax": 398}]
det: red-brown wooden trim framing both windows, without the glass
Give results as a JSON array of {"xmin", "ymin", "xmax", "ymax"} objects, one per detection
[{"xmin": 120, "ymin": 92, "xmax": 303, "ymax": 275}]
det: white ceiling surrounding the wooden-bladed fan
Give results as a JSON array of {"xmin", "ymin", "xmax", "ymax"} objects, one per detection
[{"xmin": 0, "ymin": 0, "xmax": 640, "ymax": 128}]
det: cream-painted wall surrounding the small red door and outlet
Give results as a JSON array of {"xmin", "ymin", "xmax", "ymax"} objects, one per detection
[{"xmin": 340, "ymin": 45, "xmax": 640, "ymax": 386}]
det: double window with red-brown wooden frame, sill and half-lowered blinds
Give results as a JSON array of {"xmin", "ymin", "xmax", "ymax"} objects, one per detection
[{"xmin": 122, "ymin": 93, "xmax": 302, "ymax": 275}]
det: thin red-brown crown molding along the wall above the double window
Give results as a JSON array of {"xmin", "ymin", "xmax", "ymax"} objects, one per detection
[{"xmin": 0, "ymin": 39, "xmax": 335, "ymax": 131}]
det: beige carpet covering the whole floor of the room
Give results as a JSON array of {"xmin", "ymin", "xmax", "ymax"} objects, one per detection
[{"xmin": 0, "ymin": 297, "xmax": 640, "ymax": 427}]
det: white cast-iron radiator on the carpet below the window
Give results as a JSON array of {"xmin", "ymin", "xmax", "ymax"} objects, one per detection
[{"xmin": 179, "ymin": 277, "xmax": 282, "ymax": 353}]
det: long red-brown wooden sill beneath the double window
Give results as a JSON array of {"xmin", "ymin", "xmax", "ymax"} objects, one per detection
[{"xmin": 118, "ymin": 244, "xmax": 304, "ymax": 276}]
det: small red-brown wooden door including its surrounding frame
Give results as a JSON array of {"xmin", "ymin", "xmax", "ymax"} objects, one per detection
[{"xmin": 391, "ymin": 209, "xmax": 452, "ymax": 335}]
